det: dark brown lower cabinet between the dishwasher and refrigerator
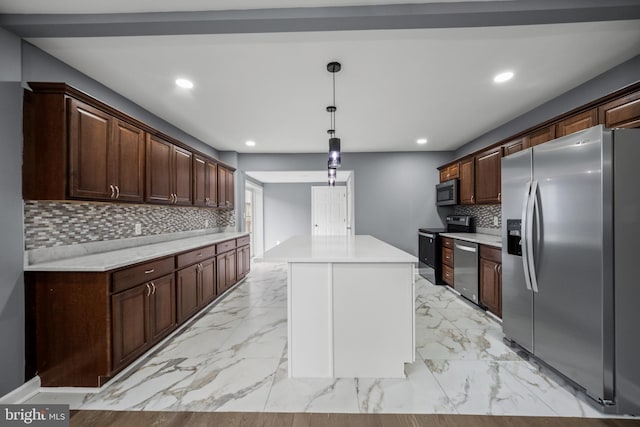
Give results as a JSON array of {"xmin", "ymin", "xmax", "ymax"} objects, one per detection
[{"xmin": 479, "ymin": 245, "xmax": 502, "ymax": 318}]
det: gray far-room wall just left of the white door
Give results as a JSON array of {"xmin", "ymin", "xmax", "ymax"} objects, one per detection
[{"xmin": 263, "ymin": 183, "xmax": 311, "ymax": 250}]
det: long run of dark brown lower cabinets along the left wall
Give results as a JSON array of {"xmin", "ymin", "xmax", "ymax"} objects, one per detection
[{"xmin": 25, "ymin": 237, "xmax": 249, "ymax": 387}]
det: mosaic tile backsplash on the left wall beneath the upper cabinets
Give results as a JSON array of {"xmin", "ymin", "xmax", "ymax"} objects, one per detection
[{"xmin": 24, "ymin": 200, "xmax": 235, "ymax": 250}]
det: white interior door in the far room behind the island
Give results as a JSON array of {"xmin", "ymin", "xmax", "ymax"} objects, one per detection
[{"xmin": 311, "ymin": 186, "xmax": 347, "ymax": 236}]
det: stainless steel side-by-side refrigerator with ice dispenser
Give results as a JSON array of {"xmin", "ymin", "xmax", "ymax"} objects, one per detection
[{"xmin": 502, "ymin": 126, "xmax": 640, "ymax": 414}]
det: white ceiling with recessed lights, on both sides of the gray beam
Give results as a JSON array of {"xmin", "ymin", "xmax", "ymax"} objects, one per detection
[{"xmin": 5, "ymin": 0, "xmax": 640, "ymax": 153}]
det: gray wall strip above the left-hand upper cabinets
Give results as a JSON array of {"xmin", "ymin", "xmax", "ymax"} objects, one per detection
[{"xmin": 22, "ymin": 41, "xmax": 219, "ymax": 158}]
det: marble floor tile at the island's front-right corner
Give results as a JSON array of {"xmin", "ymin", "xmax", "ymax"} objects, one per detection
[{"xmin": 356, "ymin": 360, "xmax": 456, "ymax": 414}]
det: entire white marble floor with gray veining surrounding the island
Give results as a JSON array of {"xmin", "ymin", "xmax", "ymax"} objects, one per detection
[{"xmin": 29, "ymin": 263, "xmax": 632, "ymax": 417}]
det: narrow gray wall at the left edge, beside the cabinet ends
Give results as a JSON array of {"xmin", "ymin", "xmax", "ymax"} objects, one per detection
[{"xmin": 0, "ymin": 28, "xmax": 25, "ymax": 396}]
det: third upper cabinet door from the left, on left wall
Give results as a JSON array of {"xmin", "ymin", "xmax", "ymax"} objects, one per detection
[{"xmin": 145, "ymin": 135, "xmax": 173, "ymax": 203}]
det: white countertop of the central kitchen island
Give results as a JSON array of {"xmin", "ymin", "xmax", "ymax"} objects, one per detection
[{"xmin": 262, "ymin": 235, "xmax": 418, "ymax": 263}]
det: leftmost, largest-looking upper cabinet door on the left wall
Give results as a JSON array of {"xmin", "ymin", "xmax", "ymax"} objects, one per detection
[{"xmin": 69, "ymin": 99, "xmax": 112, "ymax": 200}]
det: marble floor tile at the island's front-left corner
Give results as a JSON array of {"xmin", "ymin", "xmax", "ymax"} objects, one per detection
[{"xmin": 264, "ymin": 357, "xmax": 359, "ymax": 413}]
